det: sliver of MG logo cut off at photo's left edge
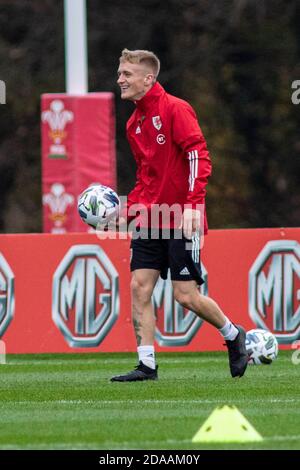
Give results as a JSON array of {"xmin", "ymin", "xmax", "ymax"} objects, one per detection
[{"xmin": 0, "ymin": 253, "xmax": 15, "ymax": 337}]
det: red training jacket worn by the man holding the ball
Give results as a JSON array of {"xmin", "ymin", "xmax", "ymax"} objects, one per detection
[{"xmin": 122, "ymin": 83, "xmax": 211, "ymax": 233}]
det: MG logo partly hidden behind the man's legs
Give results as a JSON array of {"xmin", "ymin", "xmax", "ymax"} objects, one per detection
[{"xmin": 152, "ymin": 264, "xmax": 208, "ymax": 346}]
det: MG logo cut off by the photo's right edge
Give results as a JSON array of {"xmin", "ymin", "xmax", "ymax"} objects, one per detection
[{"xmin": 249, "ymin": 240, "xmax": 300, "ymax": 344}]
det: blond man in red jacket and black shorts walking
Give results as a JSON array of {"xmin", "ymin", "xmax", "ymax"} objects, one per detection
[{"xmin": 111, "ymin": 49, "xmax": 248, "ymax": 382}]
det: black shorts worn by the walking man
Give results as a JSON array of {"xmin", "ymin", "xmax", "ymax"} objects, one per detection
[{"xmin": 130, "ymin": 230, "xmax": 204, "ymax": 285}]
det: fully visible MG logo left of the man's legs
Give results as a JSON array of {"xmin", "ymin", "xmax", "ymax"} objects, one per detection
[{"xmin": 52, "ymin": 245, "xmax": 119, "ymax": 347}]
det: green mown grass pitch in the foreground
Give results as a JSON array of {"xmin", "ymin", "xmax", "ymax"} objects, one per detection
[{"xmin": 0, "ymin": 351, "xmax": 300, "ymax": 450}]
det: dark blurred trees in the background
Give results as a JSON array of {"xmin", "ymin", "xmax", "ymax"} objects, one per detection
[{"xmin": 0, "ymin": 0, "xmax": 300, "ymax": 232}]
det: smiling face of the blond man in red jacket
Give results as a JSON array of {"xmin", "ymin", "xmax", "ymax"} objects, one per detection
[{"xmin": 117, "ymin": 62, "xmax": 154, "ymax": 101}]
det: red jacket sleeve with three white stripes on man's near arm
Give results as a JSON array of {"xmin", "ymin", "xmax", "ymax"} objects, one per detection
[{"xmin": 173, "ymin": 101, "xmax": 211, "ymax": 206}]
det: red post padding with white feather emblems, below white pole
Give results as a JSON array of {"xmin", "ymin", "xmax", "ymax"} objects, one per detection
[{"xmin": 41, "ymin": 93, "xmax": 117, "ymax": 233}]
